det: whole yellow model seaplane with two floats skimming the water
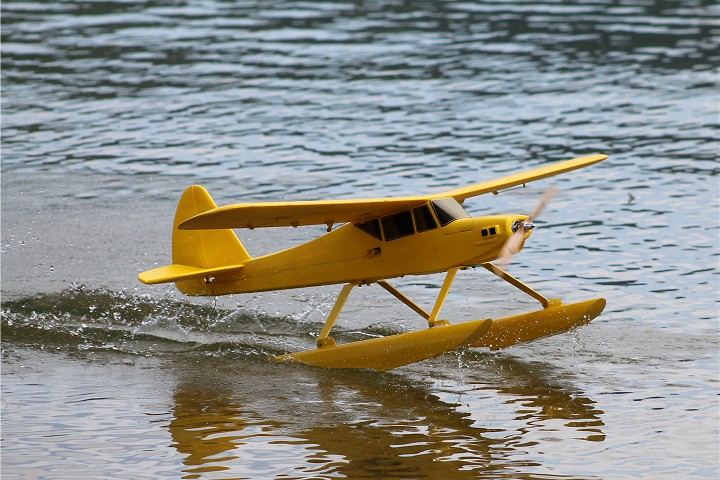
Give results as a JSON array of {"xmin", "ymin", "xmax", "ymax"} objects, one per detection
[{"xmin": 138, "ymin": 155, "xmax": 607, "ymax": 371}]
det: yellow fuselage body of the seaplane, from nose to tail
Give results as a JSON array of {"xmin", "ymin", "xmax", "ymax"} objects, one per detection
[{"xmin": 177, "ymin": 214, "xmax": 529, "ymax": 295}]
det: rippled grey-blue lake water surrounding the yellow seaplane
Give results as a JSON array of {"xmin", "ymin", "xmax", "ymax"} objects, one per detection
[{"xmin": 1, "ymin": 0, "xmax": 720, "ymax": 479}]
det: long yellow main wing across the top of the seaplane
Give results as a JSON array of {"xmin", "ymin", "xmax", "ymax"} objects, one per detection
[{"xmin": 178, "ymin": 155, "xmax": 607, "ymax": 230}]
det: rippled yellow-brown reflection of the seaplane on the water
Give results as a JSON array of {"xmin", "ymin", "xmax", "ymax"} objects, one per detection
[{"xmin": 168, "ymin": 354, "xmax": 605, "ymax": 479}]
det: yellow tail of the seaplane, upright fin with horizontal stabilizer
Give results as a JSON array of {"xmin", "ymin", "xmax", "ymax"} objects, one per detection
[{"xmin": 138, "ymin": 185, "xmax": 251, "ymax": 295}]
